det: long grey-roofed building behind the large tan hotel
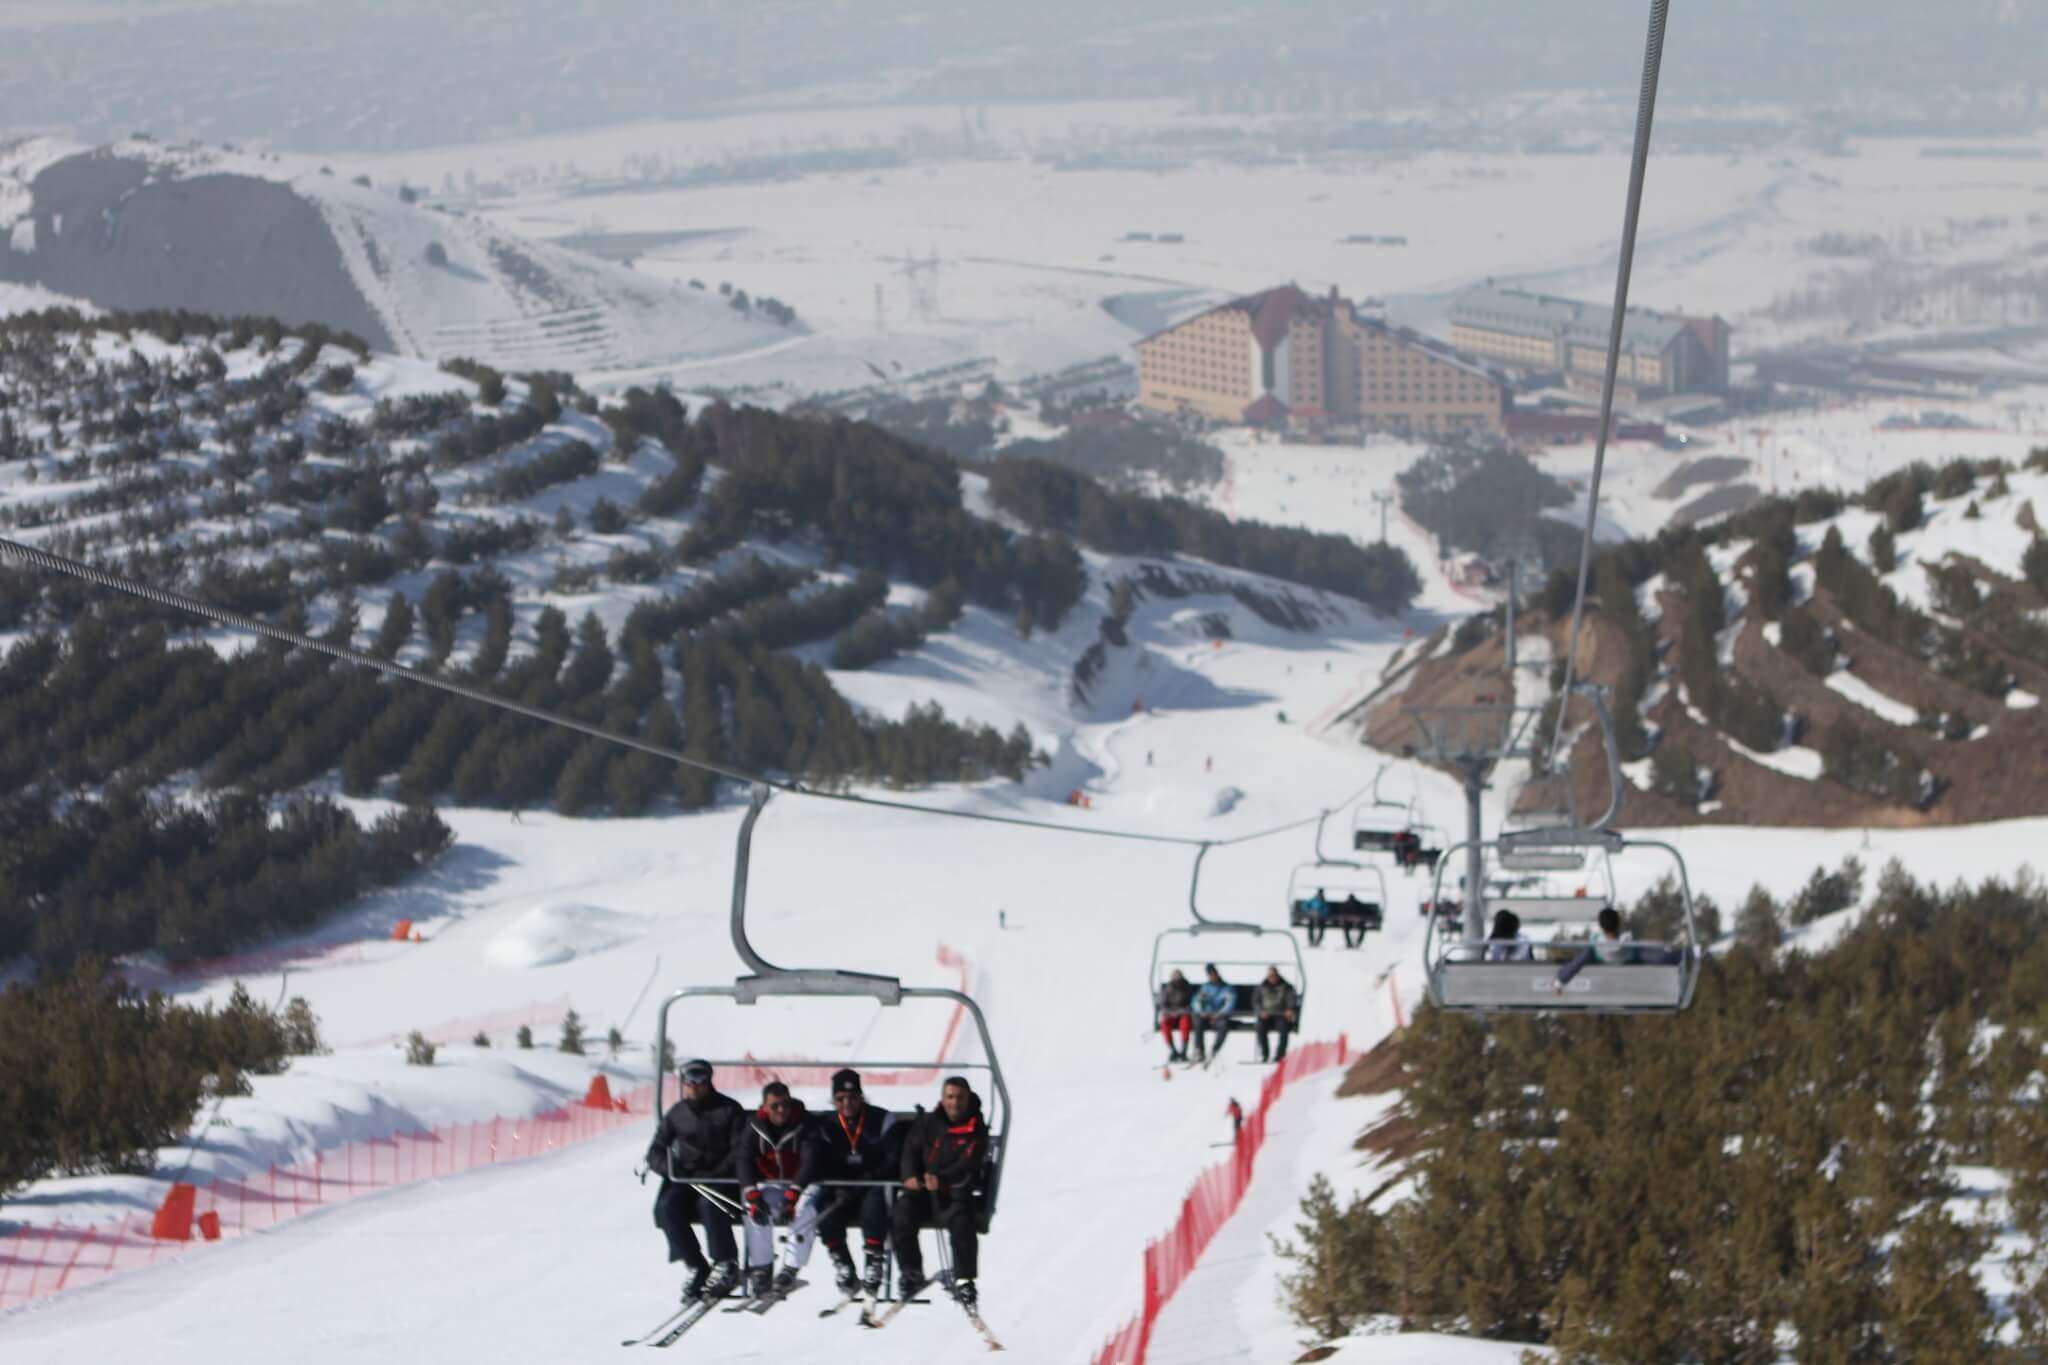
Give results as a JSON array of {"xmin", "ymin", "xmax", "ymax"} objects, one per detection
[{"xmin": 1450, "ymin": 282, "xmax": 1729, "ymax": 395}]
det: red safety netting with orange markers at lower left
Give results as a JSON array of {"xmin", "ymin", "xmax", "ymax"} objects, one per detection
[{"xmin": 0, "ymin": 1085, "xmax": 653, "ymax": 1310}]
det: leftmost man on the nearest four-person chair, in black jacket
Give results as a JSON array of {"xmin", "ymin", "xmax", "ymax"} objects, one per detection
[{"xmin": 647, "ymin": 1060, "xmax": 745, "ymax": 1300}]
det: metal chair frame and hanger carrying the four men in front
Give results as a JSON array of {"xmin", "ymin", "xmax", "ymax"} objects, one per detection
[{"xmin": 653, "ymin": 784, "xmax": 1014, "ymax": 1232}]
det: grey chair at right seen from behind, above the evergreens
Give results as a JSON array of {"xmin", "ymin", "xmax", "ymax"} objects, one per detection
[{"xmin": 1423, "ymin": 829, "xmax": 1700, "ymax": 1015}]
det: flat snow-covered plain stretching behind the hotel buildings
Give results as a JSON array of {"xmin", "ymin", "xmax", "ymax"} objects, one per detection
[{"xmin": 315, "ymin": 100, "xmax": 2042, "ymax": 395}]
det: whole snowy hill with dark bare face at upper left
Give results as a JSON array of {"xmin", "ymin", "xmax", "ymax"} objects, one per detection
[{"xmin": 0, "ymin": 139, "xmax": 803, "ymax": 375}]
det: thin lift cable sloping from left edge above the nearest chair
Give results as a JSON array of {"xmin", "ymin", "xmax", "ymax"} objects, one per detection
[{"xmin": 0, "ymin": 538, "xmax": 1356, "ymax": 849}]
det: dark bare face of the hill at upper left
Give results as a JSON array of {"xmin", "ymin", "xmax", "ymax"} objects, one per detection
[{"xmin": 0, "ymin": 151, "xmax": 391, "ymax": 350}]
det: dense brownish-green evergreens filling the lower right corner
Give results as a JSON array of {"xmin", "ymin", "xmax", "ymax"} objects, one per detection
[{"xmin": 1282, "ymin": 864, "xmax": 2048, "ymax": 1365}]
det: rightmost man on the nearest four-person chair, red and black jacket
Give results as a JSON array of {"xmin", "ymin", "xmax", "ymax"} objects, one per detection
[{"xmin": 891, "ymin": 1076, "xmax": 989, "ymax": 1308}]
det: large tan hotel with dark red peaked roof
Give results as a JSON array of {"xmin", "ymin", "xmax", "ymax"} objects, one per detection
[{"xmin": 1139, "ymin": 284, "xmax": 1505, "ymax": 434}]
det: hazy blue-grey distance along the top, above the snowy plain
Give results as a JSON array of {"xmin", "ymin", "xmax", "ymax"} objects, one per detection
[{"xmin": 0, "ymin": 0, "xmax": 2048, "ymax": 151}]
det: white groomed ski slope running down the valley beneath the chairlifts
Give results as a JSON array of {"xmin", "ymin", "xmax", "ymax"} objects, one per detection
[{"xmin": 0, "ymin": 601, "xmax": 2044, "ymax": 1365}]
